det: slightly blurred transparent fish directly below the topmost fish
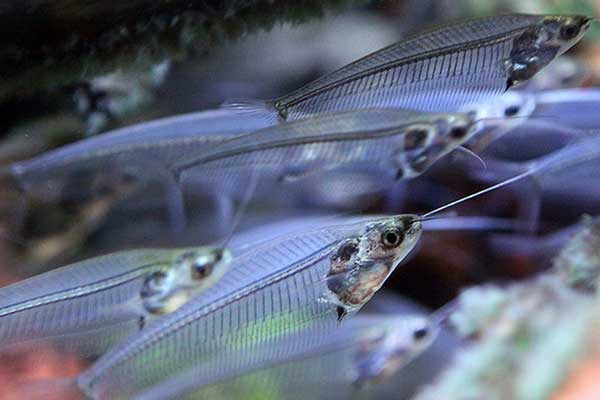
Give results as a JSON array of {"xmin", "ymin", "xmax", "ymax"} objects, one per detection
[{"xmin": 173, "ymin": 109, "xmax": 474, "ymax": 198}]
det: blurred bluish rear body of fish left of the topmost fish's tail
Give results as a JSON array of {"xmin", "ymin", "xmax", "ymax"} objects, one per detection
[{"xmin": 1, "ymin": 110, "xmax": 268, "ymax": 231}]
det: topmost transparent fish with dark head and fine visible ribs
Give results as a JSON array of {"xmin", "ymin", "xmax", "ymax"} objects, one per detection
[{"xmin": 228, "ymin": 14, "xmax": 591, "ymax": 120}]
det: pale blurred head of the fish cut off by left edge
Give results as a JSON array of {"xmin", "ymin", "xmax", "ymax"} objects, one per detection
[{"xmin": 141, "ymin": 247, "xmax": 232, "ymax": 315}]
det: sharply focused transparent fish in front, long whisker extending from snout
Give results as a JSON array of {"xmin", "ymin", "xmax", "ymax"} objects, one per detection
[{"xmin": 78, "ymin": 216, "xmax": 421, "ymax": 399}]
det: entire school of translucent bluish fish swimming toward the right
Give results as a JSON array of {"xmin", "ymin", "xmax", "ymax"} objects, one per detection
[{"xmin": 0, "ymin": 14, "xmax": 600, "ymax": 399}]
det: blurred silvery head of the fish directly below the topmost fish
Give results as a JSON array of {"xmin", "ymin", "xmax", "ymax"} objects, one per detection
[{"xmin": 393, "ymin": 114, "xmax": 476, "ymax": 179}]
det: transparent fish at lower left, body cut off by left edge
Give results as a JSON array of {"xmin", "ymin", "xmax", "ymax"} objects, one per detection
[{"xmin": 0, "ymin": 247, "xmax": 232, "ymax": 355}]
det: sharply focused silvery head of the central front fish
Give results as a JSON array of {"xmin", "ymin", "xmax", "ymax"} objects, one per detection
[{"xmin": 326, "ymin": 214, "xmax": 422, "ymax": 318}]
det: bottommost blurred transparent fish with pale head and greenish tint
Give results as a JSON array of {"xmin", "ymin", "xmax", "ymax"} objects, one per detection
[{"xmin": 135, "ymin": 315, "xmax": 437, "ymax": 400}]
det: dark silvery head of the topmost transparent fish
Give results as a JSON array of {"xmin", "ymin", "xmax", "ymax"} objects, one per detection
[{"xmin": 505, "ymin": 15, "xmax": 592, "ymax": 87}]
